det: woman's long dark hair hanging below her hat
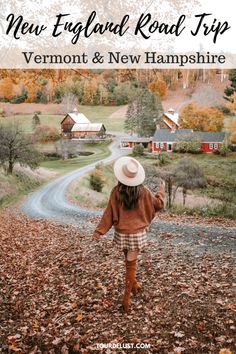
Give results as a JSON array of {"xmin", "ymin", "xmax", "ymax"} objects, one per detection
[{"xmin": 117, "ymin": 182, "xmax": 143, "ymax": 209}]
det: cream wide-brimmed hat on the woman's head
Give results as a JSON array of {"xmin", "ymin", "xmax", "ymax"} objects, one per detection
[{"xmin": 114, "ymin": 156, "xmax": 145, "ymax": 187}]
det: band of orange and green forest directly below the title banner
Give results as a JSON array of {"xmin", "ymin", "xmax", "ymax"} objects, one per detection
[{"xmin": 0, "ymin": 69, "xmax": 228, "ymax": 105}]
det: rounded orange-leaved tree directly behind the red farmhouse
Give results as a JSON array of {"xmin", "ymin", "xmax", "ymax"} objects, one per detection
[{"xmin": 179, "ymin": 103, "xmax": 224, "ymax": 132}]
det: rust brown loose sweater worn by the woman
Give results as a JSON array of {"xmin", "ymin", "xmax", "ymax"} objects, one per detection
[{"xmin": 94, "ymin": 187, "xmax": 165, "ymax": 235}]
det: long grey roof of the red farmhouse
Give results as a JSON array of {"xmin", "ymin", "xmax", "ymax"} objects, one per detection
[{"xmin": 153, "ymin": 129, "xmax": 225, "ymax": 143}]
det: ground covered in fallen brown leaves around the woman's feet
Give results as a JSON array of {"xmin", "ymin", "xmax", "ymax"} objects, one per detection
[{"xmin": 0, "ymin": 213, "xmax": 236, "ymax": 354}]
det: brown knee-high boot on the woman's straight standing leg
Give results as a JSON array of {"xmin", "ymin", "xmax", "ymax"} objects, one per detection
[{"xmin": 122, "ymin": 259, "xmax": 137, "ymax": 312}]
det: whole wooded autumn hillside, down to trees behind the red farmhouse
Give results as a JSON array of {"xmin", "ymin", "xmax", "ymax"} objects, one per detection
[{"xmin": 0, "ymin": 69, "xmax": 236, "ymax": 141}]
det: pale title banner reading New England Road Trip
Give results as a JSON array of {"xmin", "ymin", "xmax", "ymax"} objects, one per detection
[{"xmin": 0, "ymin": 0, "xmax": 236, "ymax": 69}]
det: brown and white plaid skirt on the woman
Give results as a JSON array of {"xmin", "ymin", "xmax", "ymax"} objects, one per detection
[{"xmin": 113, "ymin": 231, "xmax": 147, "ymax": 251}]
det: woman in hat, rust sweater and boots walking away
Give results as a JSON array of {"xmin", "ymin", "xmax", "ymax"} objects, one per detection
[{"xmin": 93, "ymin": 156, "xmax": 165, "ymax": 312}]
